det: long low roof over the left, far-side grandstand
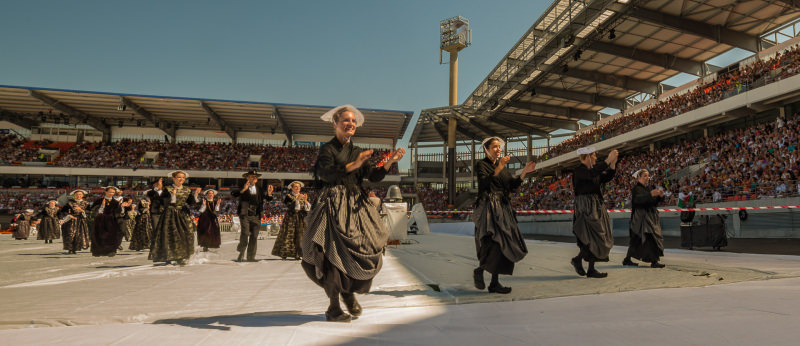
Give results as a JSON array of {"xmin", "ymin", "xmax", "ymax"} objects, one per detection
[{"xmin": 0, "ymin": 85, "xmax": 413, "ymax": 140}]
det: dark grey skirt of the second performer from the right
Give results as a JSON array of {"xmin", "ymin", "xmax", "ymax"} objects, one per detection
[{"xmin": 572, "ymin": 195, "xmax": 614, "ymax": 262}]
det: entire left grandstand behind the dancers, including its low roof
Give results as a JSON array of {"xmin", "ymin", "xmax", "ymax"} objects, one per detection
[{"xmin": 0, "ymin": 86, "xmax": 413, "ymax": 217}]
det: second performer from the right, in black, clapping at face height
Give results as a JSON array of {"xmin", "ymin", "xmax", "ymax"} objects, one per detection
[{"xmin": 570, "ymin": 147, "xmax": 619, "ymax": 278}]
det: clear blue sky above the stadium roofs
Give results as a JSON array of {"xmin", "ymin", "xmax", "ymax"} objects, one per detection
[{"xmin": 0, "ymin": 0, "xmax": 550, "ymax": 137}]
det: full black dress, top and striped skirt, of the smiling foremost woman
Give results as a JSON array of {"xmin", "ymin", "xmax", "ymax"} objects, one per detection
[{"xmin": 301, "ymin": 137, "xmax": 389, "ymax": 297}]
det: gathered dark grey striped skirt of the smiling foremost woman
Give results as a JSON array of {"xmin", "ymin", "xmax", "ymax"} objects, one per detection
[{"xmin": 301, "ymin": 185, "xmax": 389, "ymax": 293}]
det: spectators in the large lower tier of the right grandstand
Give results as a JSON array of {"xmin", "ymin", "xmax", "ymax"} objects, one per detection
[{"xmin": 514, "ymin": 114, "xmax": 800, "ymax": 209}]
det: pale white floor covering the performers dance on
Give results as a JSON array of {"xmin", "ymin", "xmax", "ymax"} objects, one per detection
[{"xmin": 0, "ymin": 227, "xmax": 800, "ymax": 345}]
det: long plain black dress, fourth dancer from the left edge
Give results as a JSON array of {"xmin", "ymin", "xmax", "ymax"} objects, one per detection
[{"xmin": 91, "ymin": 197, "xmax": 122, "ymax": 257}]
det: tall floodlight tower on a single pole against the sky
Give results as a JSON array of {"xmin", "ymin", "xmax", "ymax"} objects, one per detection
[{"xmin": 439, "ymin": 16, "xmax": 472, "ymax": 205}]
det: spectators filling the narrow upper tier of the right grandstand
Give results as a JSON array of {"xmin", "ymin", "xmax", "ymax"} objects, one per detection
[{"xmin": 540, "ymin": 45, "xmax": 800, "ymax": 160}]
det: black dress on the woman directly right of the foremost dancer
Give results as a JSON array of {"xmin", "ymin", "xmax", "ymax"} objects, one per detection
[{"xmin": 473, "ymin": 158, "xmax": 528, "ymax": 275}]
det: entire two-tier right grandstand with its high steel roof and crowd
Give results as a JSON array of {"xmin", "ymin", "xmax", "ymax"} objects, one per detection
[{"xmin": 404, "ymin": 0, "xmax": 800, "ymax": 237}]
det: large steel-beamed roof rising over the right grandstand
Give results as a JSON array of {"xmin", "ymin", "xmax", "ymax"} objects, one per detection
[{"xmin": 411, "ymin": 0, "xmax": 800, "ymax": 142}]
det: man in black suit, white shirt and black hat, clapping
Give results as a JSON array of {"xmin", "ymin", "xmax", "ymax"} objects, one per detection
[{"xmin": 231, "ymin": 169, "xmax": 273, "ymax": 262}]
